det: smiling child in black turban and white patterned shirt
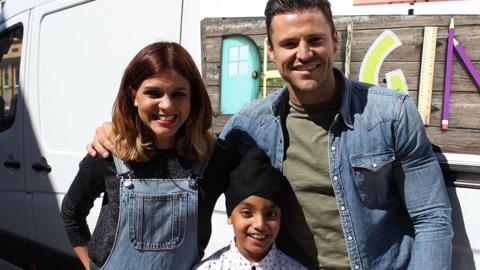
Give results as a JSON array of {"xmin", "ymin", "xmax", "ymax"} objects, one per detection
[{"xmin": 196, "ymin": 148, "xmax": 306, "ymax": 270}]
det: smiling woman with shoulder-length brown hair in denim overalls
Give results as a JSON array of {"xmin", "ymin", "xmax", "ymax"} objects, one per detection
[{"xmin": 61, "ymin": 42, "xmax": 238, "ymax": 269}]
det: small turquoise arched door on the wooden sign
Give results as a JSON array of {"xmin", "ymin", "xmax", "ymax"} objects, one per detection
[{"xmin": 220, "ymin": 36, "xmax": 260, "ymax": 114}]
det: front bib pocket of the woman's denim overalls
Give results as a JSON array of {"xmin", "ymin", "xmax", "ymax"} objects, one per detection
[{"xmin": 128, "ymin": 192, "xmax": 188, "ymax": 250}]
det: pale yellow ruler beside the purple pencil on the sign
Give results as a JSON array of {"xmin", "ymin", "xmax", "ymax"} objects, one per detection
[{"xmin": 417, "ymin": 27, "xmax": 437, "ymax": 125}]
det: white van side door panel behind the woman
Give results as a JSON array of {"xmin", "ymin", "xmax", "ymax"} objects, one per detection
[{"xmin": 25, "ymin": 0, "xmax": 182, "ymax": 254}]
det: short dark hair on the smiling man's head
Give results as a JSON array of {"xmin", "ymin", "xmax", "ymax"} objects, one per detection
[{"xmin": 265, "ymin": 0, "xmax": 335, "ymax": 45}]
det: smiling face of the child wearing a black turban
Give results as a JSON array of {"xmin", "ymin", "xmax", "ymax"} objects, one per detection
[{"xmin": 228, "ymin": 196, "xmax": 281, "ymax": 262}]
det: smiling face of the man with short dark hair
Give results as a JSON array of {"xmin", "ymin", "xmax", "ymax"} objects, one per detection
[{"xmin": 268, "ymin": 9, "xmax": 338, "ymax": 104}]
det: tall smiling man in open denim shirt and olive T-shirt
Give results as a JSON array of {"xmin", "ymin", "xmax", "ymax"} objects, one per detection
[{"xmin": 87, "ymin": 0, "xmax": 453, "ymax": 269}]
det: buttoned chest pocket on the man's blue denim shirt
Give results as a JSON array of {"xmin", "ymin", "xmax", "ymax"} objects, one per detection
[{"xmin": 350, "ymin": 150, "xmax": 395, "ymax": 208}]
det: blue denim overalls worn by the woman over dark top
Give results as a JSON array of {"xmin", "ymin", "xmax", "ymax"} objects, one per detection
[{"xmin": 90, "ymin": 150, "xmax": 213, "ymax": 270}]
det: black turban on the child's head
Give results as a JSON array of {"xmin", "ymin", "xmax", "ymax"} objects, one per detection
[{"xmin": 225, "ymin": 148, "xmax": 288, "ymax": 216}]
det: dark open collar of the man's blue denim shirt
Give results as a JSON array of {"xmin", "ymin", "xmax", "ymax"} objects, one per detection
[{"xmin": 272, "ymin": 68, "xmax": 353, "ymax": 129}]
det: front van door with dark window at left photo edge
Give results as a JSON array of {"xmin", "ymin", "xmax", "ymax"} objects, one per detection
[{"xmin": 0, "ymin": 8, "xmax": 31, "ymax": 262}]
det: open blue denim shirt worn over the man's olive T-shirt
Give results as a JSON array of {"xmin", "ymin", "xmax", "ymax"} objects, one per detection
[{"xmin": 220, "ymin": 69, "xmax": 453, "ymax": 270}]
